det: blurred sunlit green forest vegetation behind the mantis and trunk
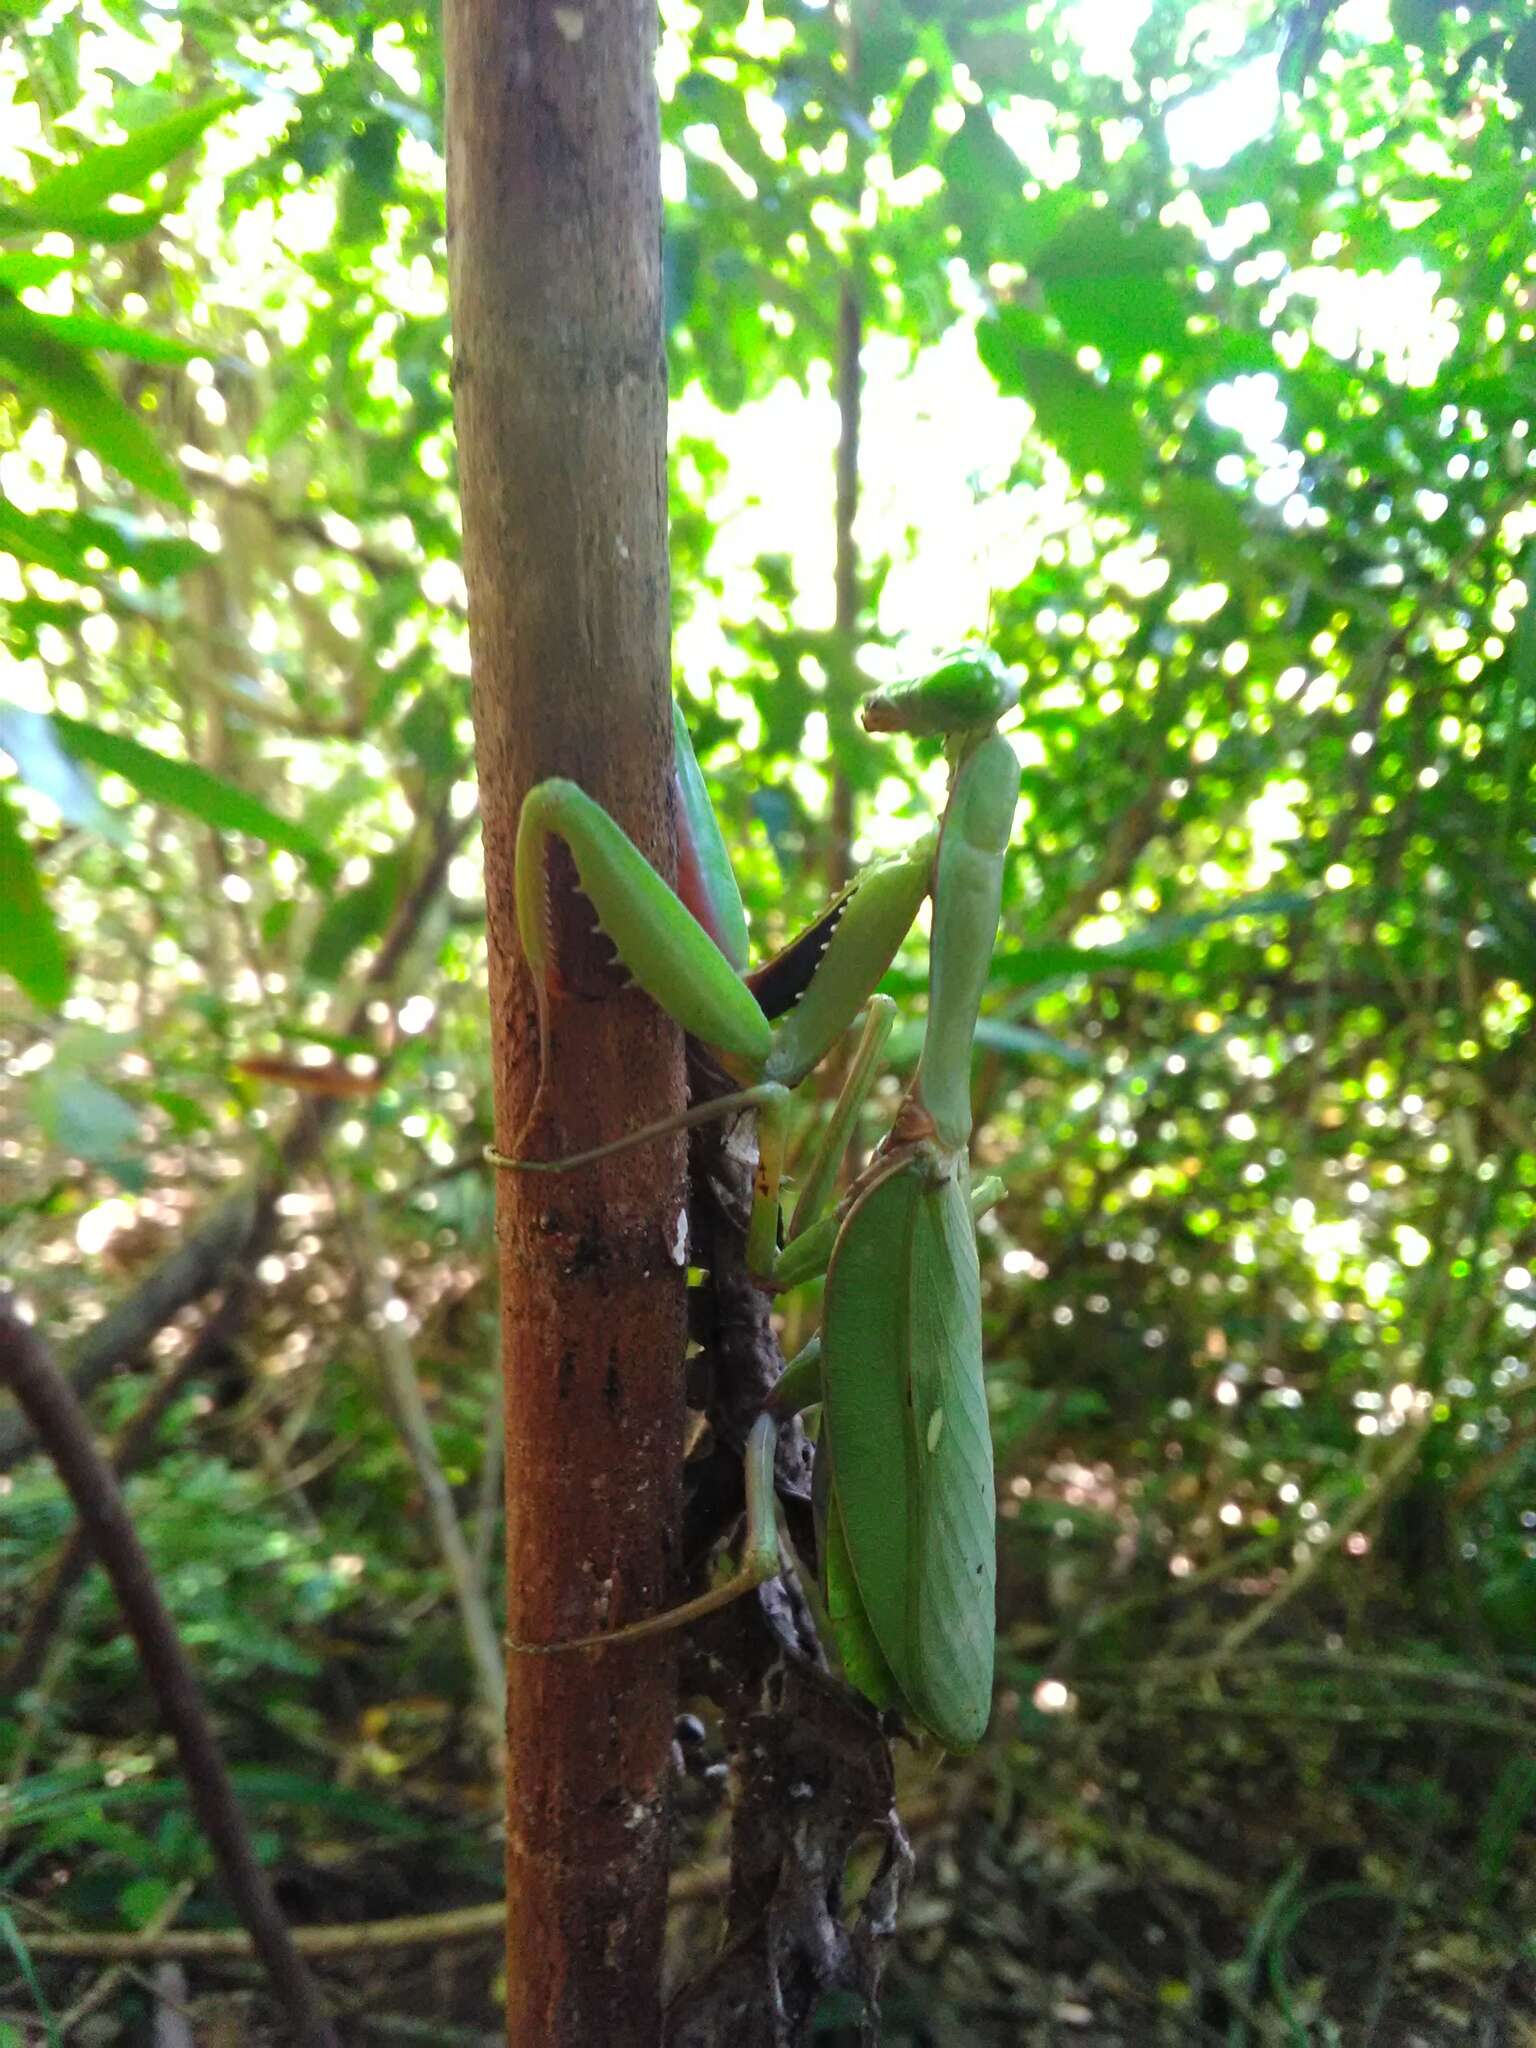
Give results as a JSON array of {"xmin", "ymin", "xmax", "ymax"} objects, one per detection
[{"xmin": 0, "ymin": 0, "xmax": 1536, "ymax": 2044}]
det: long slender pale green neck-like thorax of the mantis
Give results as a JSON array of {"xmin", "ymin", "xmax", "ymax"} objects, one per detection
[{"xmin": 913, "ymin": 733, "xmax": 1020, "ymax": 1151}]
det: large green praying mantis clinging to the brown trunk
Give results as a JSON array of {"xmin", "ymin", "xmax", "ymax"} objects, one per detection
[{"xmin": 487, "ymin": 645, "xmax": 1020, "ymax": 1751}]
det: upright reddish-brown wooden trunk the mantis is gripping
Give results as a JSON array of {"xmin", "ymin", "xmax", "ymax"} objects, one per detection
[{"xmin": 444, "ymin": 0, "xmax": 684, "ymax": 2048}]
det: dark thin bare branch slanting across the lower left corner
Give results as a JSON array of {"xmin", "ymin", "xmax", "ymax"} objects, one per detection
[{"xmin": 0, "ymin": 1296, "xmax": 336, "ymax": 2048}]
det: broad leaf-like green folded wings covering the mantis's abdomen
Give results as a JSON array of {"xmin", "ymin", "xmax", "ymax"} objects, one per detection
[{"xmin": 819, "ymin": 1147, "xmax": 997, "ymax": 1751}]
